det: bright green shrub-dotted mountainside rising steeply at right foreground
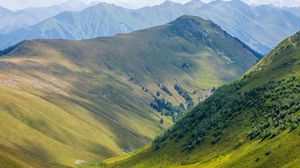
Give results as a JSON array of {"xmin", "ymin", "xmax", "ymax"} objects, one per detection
[{"xmin": 98, "ymin": 32, "xmax": 300, "ymax": 168}]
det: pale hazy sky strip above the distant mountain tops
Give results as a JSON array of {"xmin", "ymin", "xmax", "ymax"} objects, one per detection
[{"xmin": 0, "ymin": 0, "xmax": 300, "ymax": 10}]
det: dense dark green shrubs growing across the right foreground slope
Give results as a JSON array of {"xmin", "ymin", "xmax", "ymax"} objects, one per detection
[{"xmin": 154, "ymin": 79, "xmax": 300, "ymax": 150}]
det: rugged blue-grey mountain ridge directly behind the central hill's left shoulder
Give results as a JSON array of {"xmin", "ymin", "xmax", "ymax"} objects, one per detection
[{"xmin": 0, "ymin": 2, "xmax": 183, "ymax": 48}]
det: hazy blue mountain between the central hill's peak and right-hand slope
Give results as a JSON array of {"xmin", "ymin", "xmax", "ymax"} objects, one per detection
[{"xmin": 196, "ymin": 0, "xmax": 300, "ymax": 54}]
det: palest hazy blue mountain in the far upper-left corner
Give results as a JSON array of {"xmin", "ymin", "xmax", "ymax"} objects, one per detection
[{"xmin": 0, "ymin": 0, "xmax": 90, "ymax": 34}]
